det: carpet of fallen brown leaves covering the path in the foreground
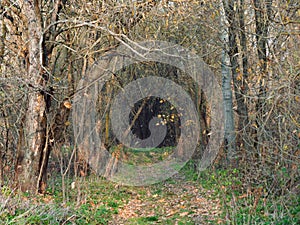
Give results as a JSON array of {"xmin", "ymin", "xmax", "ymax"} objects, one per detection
[{"xmin": 114, "ymin": 178, "xmax": 221, "ymax": 224}]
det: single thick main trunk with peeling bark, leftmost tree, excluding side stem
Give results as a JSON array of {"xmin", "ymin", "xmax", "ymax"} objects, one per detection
[{"xmin": 16, "ymin": 0, "xmax": 46, "ymax": 193}]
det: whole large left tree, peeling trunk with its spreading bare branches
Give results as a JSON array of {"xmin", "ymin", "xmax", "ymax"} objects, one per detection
[{"xmin": 7, "ymin": 0, "xmax": 156, "ymax": 193}]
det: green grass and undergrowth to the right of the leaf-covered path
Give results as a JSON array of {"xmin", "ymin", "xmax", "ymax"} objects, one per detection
[{"xmin": 198, "ymin": 165, "xmax": 300, "ymax": 225}]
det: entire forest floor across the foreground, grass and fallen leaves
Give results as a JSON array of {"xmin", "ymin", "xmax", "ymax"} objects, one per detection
[{"xmin": 0, "ymin": 164, "xmax": 300, "ymax": 225}]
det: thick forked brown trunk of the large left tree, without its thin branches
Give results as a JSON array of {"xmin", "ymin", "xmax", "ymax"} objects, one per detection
[{"xmin": 12, "ymin": 0, "xmax": 64, "ymax": 192}]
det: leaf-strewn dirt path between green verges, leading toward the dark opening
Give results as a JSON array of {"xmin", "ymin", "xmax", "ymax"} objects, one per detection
[{"xmin": 110, "ymin": 175, "xmax": 221, "ymax": 225}]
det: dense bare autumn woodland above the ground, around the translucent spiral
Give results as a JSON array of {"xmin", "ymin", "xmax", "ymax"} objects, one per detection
[{"xmin": 0, "ymin": 0, "xmax": 300, "ymax": 224}]
